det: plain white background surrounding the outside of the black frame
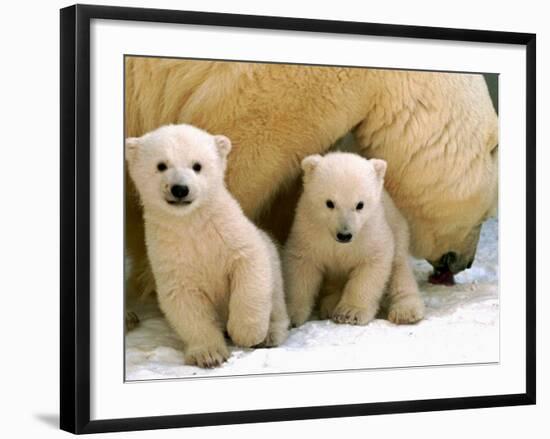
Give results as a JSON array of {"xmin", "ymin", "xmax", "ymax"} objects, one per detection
[{"xmin": 0, "ymin": 0, "xmax": 550, "ymax": 438}]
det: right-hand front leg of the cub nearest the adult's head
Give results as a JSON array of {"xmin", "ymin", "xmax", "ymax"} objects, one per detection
[{"xmin": 332, "ymin": 257, "xmax": 391, "ymax": 325}]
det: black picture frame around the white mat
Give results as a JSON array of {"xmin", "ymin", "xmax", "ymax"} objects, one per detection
[{"xmin": 60, "ymin": 5, "xmax": 536, "ymax": 433}]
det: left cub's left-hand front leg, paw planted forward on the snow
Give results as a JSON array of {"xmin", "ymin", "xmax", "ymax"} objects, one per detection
[{"xmin": 158, "ymin": 288, "xmax": 229, "ymax": 367}]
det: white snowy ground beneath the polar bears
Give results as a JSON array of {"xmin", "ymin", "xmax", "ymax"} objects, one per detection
[{"xmin": 126, "ymin": 219, "xmax": 499, "ymax": 381}]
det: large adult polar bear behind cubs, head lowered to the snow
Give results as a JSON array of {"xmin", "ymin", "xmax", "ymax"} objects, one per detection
[{"xmin": 125, "ymin": 57, "xmax": 498, "ymax": 291}]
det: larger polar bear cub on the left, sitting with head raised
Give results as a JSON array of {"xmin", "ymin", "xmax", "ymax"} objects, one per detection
[{"xmin": 126, "ymin": 125, "xmax": 289, "ymax": 367}]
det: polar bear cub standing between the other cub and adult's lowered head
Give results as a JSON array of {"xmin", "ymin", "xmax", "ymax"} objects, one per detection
[{"xmin": 283, "ymin": 152, "xmax": 424, "ymax": 326}]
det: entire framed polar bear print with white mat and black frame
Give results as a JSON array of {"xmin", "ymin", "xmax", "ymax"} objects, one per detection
[{"xmin": 61, "ymin": 5, "xmax": 536, "ymax": 433}]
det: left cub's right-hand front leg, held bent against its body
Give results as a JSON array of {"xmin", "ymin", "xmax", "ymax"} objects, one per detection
[{"xmin": 227, "ymin": 251, "xmax": 274, "ymax": 347}]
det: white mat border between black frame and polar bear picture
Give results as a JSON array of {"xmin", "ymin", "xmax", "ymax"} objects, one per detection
[{"xmin": 91, "ymin": 20, "xmax": 525, "ymax": 419}]
